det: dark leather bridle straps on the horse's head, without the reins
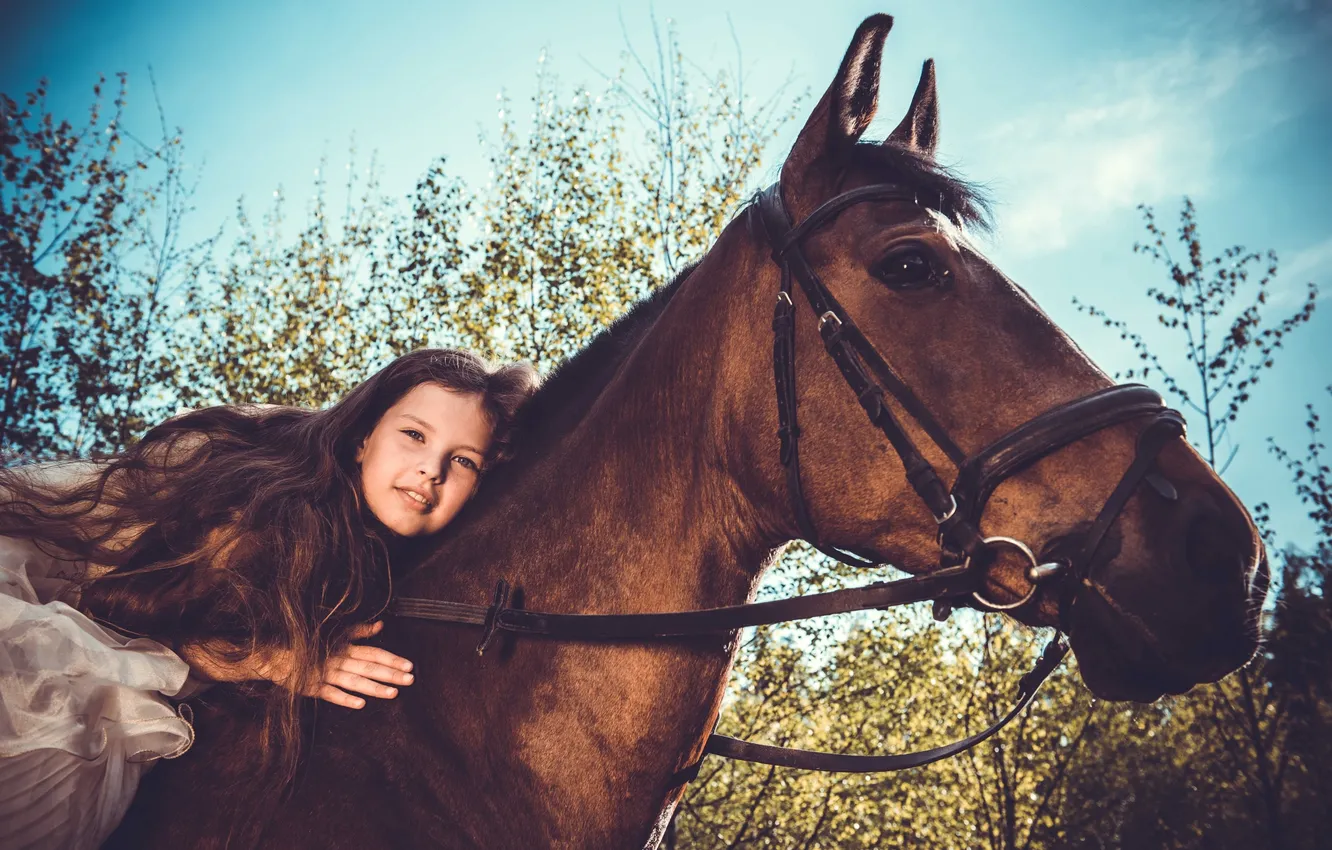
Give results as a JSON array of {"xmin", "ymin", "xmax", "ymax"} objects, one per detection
[{"xmin": 757, "ymin": 184, "xmax": 1184, "ymax": 610}]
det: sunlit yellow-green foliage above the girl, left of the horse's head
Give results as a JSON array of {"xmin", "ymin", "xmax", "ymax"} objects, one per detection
[{"xmin": 165, "ymin": 26, "xmax": 790, "ymax": 406}]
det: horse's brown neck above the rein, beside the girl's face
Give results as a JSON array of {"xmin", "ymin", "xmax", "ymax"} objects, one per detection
[{"xmin": 412, "ymin": 241, "xmax": 771, "ymax": 613}]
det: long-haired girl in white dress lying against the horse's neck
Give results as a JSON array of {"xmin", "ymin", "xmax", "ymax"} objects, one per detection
[{"xmin": 0, "ymin": 349, "xmax": 535, "ymax": 847}]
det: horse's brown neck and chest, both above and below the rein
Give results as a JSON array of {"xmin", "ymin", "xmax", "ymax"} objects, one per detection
[{"xmin": 394, "ymin": 237, "xmax": 771, "ymax": 847}]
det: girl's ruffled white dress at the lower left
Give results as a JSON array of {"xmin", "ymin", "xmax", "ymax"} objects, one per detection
[{"xmin": 0, "ymin": 466, "xmax": 194, "ymax": 850}]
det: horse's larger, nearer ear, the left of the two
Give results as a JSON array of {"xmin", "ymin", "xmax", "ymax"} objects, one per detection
[{"xmin": 782, "ymin": 15, "xmax": 892, "ymax": 194}]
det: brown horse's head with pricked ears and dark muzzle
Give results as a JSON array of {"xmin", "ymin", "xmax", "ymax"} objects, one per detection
[{"xmin": 750, "ymin": 16, "xmax": 1267, "ymax": 701}]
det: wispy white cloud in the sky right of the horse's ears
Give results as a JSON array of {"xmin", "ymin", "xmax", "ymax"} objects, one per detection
[{"xmin": 984, "ymin": 40, "xmax": 1283, "ymax": 256}]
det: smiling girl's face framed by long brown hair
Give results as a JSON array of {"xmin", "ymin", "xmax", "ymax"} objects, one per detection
[{"xmin": 356, "ymin": 384, "xmax": 492, "ymax": 537}]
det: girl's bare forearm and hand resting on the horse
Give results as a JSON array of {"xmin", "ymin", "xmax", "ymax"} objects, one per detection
[{"xmin": 177, "ymin": 620, "xmax": 413, "ymax": 709}]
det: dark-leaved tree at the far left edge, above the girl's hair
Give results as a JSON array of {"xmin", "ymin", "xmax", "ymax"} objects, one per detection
[{"xmin": 0, "ymin": 75, "xmax": 210, "ymax": 458}]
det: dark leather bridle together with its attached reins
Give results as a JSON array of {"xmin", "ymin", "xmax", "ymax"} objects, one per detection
[{"xmin": 389, "ymin": 184, "xmax": 1184, "ymax": 782}]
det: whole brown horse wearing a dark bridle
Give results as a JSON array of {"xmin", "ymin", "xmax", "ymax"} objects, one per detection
[{"xmin": 112, "ymin": 16, "xmax": 1263, "ymax": 850}]
